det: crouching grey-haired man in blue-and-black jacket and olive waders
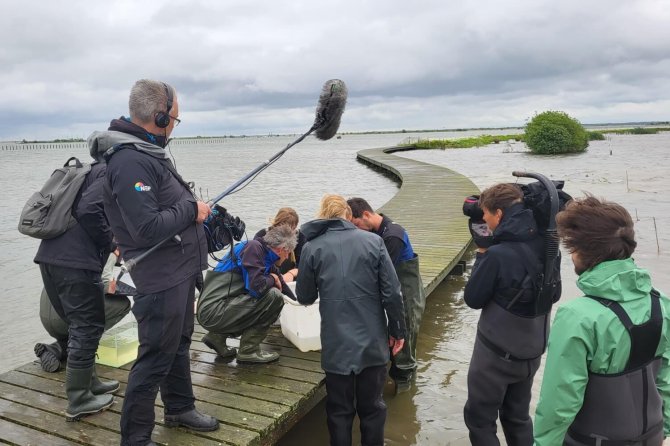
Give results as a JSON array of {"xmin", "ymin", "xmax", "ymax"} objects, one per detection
[{"xmin": 197, "ymin": 225, "xmax": 297, "ymax": 363}]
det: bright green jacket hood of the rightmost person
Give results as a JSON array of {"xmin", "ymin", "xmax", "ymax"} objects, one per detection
[{"xmin": 577, "ymin": 258, "xmax": 651, "ymax": 302}]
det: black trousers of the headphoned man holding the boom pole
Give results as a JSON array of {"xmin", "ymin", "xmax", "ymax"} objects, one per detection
[{"xmin": 121, "ymin": 276, "xmax": 196, "ymax": 446}]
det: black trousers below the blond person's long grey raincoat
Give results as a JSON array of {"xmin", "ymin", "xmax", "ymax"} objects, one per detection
[{"xmin": 326, "ymin": 365, "xmax": 386, "ymax": 446}]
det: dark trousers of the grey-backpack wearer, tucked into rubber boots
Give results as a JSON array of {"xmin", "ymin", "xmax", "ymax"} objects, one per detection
[{"xmin": 40, "ymin": 263, "xmax": 105, "ymax": 369}]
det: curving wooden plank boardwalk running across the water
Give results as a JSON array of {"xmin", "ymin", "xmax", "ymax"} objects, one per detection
[{"xmin": 0, "ymin": 148, "xmax": 484, "ymax": 446}]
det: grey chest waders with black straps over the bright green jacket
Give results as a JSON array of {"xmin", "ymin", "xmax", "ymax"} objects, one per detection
[{"xmin": 564, "ymin": 289, "xmax": 663, "ymax": 446}]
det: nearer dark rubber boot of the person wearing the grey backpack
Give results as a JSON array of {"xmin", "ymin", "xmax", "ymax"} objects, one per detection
[{"xmin": 65, "ymin": 366, "xmax": 114, "ymax": 421}]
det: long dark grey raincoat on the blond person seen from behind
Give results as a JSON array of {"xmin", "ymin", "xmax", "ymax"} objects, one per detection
[{"xmin": 296, "ymin": 218, "xmax": 405, "ymax": 375}]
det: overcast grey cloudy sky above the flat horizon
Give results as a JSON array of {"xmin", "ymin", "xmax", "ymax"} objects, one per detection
[{"xmin": 0, "ymin": 0, "xmax": 670, "ymax": 140}]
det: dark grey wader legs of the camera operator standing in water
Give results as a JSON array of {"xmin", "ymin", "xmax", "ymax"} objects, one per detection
[{"xmin": 463, "ymin": 337, "xmax": 541, "ymax": 446}]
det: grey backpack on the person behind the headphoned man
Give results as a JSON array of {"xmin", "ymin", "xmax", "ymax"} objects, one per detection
[{"xmin": 19, "ymin": 156, "xmax": 91, "ymax": 239}]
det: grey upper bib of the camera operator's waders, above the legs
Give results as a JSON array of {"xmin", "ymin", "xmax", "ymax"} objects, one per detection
[{"xmin": 477, "ymin": 242, "xmax": 551, "ymax": 361}]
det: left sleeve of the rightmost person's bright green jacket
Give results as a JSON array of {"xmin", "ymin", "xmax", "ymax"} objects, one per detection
[{"xmin": 534, "ymin": 306, "xmax": 591, "ymax": 446}]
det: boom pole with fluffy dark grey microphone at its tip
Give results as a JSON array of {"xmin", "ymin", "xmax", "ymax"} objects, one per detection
[{"xmin": 117, "ymin": 79, "xmax": 347, "ymax": 280}]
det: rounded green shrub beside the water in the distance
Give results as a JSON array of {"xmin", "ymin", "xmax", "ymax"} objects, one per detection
[{"xmin": 525, "ymin": 111, "xmax": 589, "ymax": 155}]
